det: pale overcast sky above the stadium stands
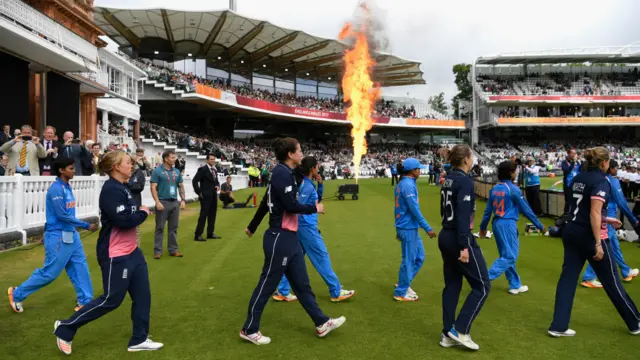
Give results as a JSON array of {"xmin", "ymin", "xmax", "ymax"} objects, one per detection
[{"xmin": 96, "ymin": 0, "xmax": 640, "ymax": 108}]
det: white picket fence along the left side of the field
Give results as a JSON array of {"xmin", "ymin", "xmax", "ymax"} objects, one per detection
[{"xmin": 0, "ymin": 175, "xmax": 249, "ymax": 248}]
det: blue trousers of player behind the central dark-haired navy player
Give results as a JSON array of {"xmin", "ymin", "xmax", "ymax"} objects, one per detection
[{"xmin": 278, "ymin": 226, "xmax": 342, "ymax": 298}]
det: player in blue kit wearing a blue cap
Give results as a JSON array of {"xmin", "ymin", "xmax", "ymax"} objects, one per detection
[{"xmin": 393, "ymin": 158, "xmax": 436, "ymax": 301}]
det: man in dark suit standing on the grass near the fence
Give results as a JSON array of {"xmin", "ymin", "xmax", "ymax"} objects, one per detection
[{"xmin": 192, "ymin": 154, "xmax": 220, "ymax": 241}]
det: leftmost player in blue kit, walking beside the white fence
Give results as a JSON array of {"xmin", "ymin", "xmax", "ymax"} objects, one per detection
[{"xmin": 7, "ymin": 159, "xmax": 98, "ymax": 313}]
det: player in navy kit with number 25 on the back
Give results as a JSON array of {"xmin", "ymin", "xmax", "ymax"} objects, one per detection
[{"xmin": 438, "ymin": 145, "xmax": 491, "ymax": 350}]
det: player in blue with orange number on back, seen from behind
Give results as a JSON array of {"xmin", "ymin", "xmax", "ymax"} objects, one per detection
[{"xmin": 480, "ymin": 161, "xmax": 544, "ymax": 295}]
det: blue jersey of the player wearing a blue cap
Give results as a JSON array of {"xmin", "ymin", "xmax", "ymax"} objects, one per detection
[{"xmin": 394, "ymin": 176, "xmax": 431, "ymax": 232}]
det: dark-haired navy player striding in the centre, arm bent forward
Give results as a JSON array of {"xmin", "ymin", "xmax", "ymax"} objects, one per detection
[{"xmin": 240, "ymin": 138, "xmax": 346, "ymax": 345}]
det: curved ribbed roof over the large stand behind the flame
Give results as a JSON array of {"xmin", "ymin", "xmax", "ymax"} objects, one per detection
[{"xmin": 94, "ymin": 7, "xmax": 425, "ymax": 86}]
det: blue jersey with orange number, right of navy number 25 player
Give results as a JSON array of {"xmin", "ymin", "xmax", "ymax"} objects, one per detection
[{"xmin": 480, "ymin": 181, "xmax": 544, "ymax": 230}]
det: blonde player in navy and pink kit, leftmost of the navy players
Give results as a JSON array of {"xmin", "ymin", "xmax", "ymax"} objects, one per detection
[{"xmin": 54, "ymin": 151, "xmax": 163, "ymax": 355}]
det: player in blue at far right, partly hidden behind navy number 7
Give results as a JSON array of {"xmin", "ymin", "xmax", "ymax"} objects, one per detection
[{"xmin": 580, "ymin": 160, "xmax": 640, "ymax": 288}]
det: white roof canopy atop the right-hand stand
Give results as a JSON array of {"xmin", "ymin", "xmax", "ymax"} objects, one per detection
[{"xmin": 476, "ymin": 43, "xmax": 640, "ymax": 65}]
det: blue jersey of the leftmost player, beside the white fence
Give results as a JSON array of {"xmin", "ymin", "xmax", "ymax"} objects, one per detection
[{"xmin": 44, "ymin": 178, "xmax": 90, "ymax": 231}]
